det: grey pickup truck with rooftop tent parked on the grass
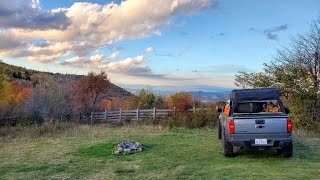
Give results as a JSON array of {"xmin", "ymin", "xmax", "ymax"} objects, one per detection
[{"xmin": 217, "ymin": 88, "xmax": 293, "ymax": 157}]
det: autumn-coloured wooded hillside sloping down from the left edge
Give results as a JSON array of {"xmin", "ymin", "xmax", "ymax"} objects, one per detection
[{"xmin": 0, "ymin": 62, "xmax": 132, "ymax": 125}]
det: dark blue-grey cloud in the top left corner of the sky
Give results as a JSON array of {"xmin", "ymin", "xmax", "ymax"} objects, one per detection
[{"xmin": 0, "ymin": 0, "xmax": 70, "ymax": 30}]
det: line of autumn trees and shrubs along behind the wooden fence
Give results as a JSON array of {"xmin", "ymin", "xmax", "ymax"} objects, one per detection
[{"xmin": 0, "ymin": 69, "xmax": 216, "ymax": 125}]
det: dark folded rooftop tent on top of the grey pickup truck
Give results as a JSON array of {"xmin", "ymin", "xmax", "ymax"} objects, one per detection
[{"xmin": 230, "ymin": 88, "xmax": 280, "ymax": 102}]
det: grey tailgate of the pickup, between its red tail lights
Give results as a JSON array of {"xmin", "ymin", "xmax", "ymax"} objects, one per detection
[{"xmin": 234, "ymin": 116, "xmax": 288, "ymax": 134}]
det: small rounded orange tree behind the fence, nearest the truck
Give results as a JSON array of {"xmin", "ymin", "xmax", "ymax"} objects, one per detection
[{"xmin": 168, "ymin": 92, "xmax": 193, "ymax": 111}]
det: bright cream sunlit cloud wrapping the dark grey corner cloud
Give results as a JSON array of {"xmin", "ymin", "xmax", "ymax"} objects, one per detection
[{"xmin": 3, "ymin": 0, "xmax": 213, "ymax": 46}]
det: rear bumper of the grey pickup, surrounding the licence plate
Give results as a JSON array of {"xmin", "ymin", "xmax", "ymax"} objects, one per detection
[{"xmin": 229, "ymin": 133, "xmax": 292, "ymax": 147}]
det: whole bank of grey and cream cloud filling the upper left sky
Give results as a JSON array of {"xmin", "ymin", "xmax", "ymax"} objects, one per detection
[{"xmin": 0, "ymin": 0, "xmax": 214, "ymax": 69}]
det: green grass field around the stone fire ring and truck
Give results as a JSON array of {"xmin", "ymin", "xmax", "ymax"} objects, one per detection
[{"xmin": 0, "ymin": 125, "xmax": 320, "ymax": 179}]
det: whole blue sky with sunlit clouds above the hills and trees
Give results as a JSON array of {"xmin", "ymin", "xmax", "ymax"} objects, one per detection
[{"xmin": 0, "ymin": 0, "xmax": 320, "ymax": 91}]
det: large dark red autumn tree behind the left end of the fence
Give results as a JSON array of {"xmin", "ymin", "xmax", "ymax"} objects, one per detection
[{"xmin": 72, "ymin": 72, "xmax": 110, "ymax": 113}]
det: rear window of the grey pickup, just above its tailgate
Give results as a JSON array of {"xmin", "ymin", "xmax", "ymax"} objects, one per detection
[{"xmin": 233, "ymin": 100, "xmax": 282, "ymax": 115}]
